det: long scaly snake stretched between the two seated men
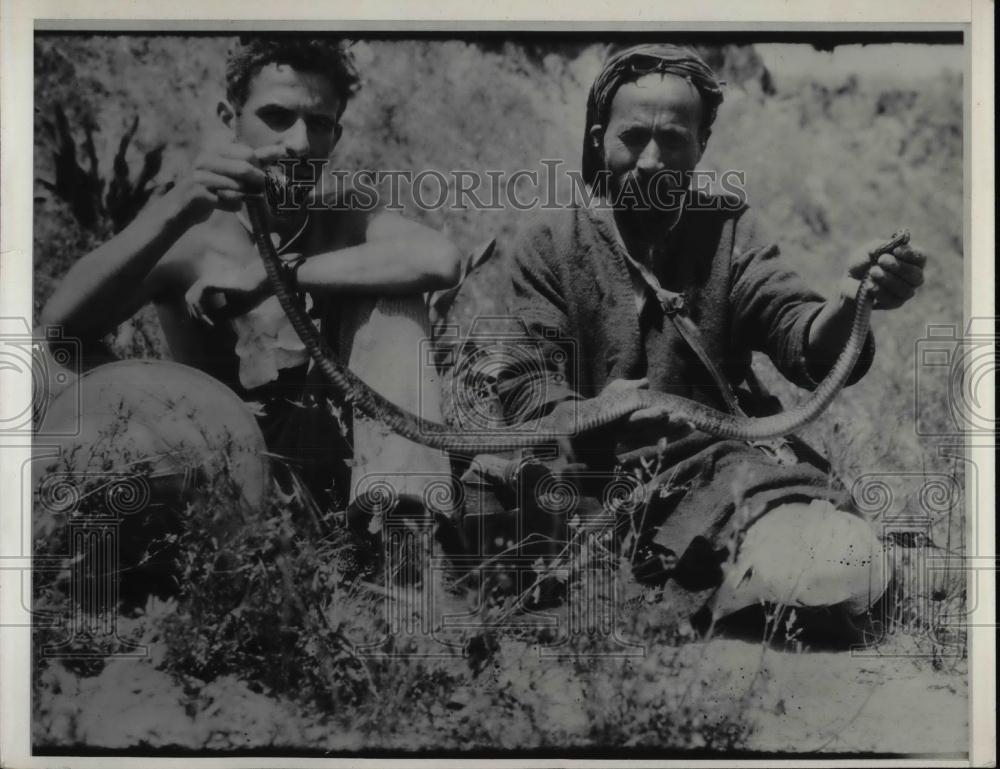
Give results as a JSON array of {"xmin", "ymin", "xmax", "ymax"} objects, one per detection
[{"xmin": 246, "ymin": 172, "xmax": 910, "ymax": 455}]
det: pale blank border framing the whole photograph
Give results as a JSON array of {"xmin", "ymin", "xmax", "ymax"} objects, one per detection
[{"xmin": 0, "ymin": 0, "xmax": 996, "ymax": 767}]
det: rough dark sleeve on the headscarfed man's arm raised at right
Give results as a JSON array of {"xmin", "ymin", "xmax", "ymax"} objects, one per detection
[{"xmin": 730, "ymin": 211, "xmax": 875, "ymax": 390}]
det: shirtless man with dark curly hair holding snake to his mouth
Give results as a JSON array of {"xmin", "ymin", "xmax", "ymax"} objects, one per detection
[{"xmin": 41, "ymin": 35, "xmax": 460, "ymax": 508}]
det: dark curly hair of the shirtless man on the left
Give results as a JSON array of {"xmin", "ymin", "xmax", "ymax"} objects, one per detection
[{"xmin": 226, "ymin": 34, "xmax": 360, "ymax": 118}]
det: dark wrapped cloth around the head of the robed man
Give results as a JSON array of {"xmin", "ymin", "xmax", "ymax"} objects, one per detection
[{"xmin": 583, "ymin": 43, "xmax": 722, "ymax": 192}]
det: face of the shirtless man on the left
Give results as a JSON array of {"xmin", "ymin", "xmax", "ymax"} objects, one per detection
[{"xmin": 234, "ymin": 64, "xmax": 340, "ymax": 175}]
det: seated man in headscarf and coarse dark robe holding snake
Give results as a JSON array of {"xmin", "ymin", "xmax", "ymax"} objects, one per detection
[{"xmin": 488, "ymin": 45, "xmax": 925, "ymax": 640}]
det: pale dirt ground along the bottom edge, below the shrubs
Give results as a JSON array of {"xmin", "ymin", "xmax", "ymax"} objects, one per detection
[{"xmin": 35, "ymin": 639, "xmax": 968, "ymax": 757}]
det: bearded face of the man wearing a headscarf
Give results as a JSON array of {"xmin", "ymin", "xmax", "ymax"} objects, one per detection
[{"xmin": 599, "ymin": 72, "xmax": 703, "ymax": 210}]
